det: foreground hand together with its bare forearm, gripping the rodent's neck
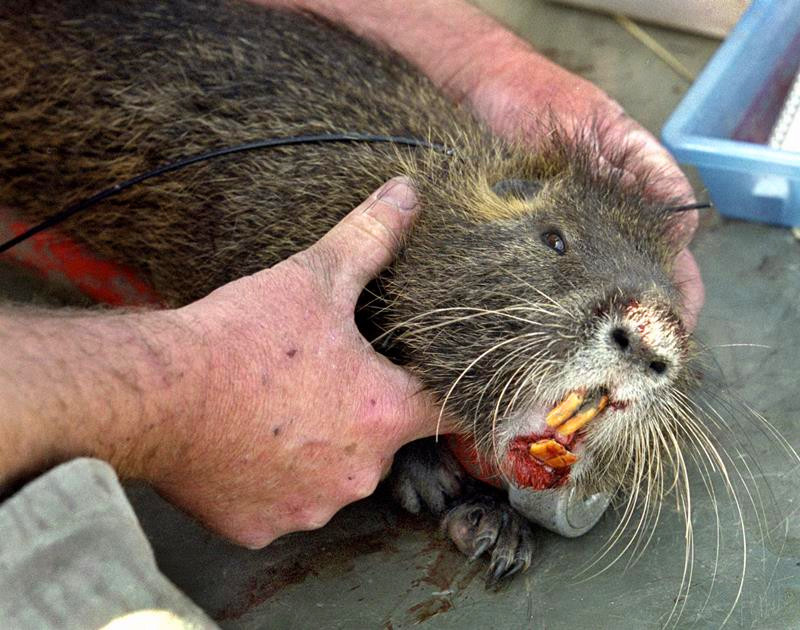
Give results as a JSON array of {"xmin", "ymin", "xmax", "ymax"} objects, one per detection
[{"xmin": 0, "ymin": 179, "xmax": 450, "ymax": 547}]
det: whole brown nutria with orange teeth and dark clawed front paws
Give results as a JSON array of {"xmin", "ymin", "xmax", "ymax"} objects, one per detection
[{"xmin": 0, "ymin": 0, "xmax": 719, "ymax": 582}]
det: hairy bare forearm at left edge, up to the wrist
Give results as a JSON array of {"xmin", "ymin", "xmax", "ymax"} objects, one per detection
[{"xmin": 0, "ymin": 307, "xmax": 203, "ymax": 487}]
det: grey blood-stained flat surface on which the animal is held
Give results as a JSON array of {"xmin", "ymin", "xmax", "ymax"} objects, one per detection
[{"xmin": 0, "ymin": 0, "xmax": 800, "ymax": 630}]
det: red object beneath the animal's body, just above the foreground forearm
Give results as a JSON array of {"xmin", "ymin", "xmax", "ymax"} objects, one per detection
[{"xmin": 0, "ymin": 212, "xmax": 162, "ymax": 306}]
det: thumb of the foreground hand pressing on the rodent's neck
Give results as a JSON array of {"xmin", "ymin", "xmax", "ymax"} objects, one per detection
[{"xmin": 306, "ymin": 177, "xmax": 419, "ymax": 304}]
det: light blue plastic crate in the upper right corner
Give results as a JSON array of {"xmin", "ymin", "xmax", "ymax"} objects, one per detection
[{"xmin": 662, "ymin": 0, "xmax": 800, "ymax": 227}]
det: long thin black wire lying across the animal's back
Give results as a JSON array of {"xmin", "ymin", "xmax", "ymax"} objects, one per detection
[{"xmin": 0, "ymin": 132, "xmax": 455, "ymax": 254}]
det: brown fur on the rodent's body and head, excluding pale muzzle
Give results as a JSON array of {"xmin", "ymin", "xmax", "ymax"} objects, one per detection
[{"xmin": 0, "ymin": 0, "xmax": 691, "ymax": 502}]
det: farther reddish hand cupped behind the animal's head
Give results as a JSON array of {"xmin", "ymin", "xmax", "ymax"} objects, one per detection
[{"xmin": 451, "ymin": 44, "xmax": 705, "ymax": 330}]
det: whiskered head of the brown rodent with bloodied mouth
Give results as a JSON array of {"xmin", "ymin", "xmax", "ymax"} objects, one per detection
[{"xmin": 388, "ymin": 133, "xmax": 694, "ymax": 504}]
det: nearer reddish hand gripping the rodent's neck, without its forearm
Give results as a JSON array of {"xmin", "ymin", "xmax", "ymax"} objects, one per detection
[{"xmin": 146, "ymin": 178, "xmax": 439, "ymax": 547}]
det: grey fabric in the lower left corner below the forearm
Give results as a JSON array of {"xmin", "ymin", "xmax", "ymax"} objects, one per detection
[{"xmin": 0, "ymin": 459, "xmax": 217, "ymax": 630}]
